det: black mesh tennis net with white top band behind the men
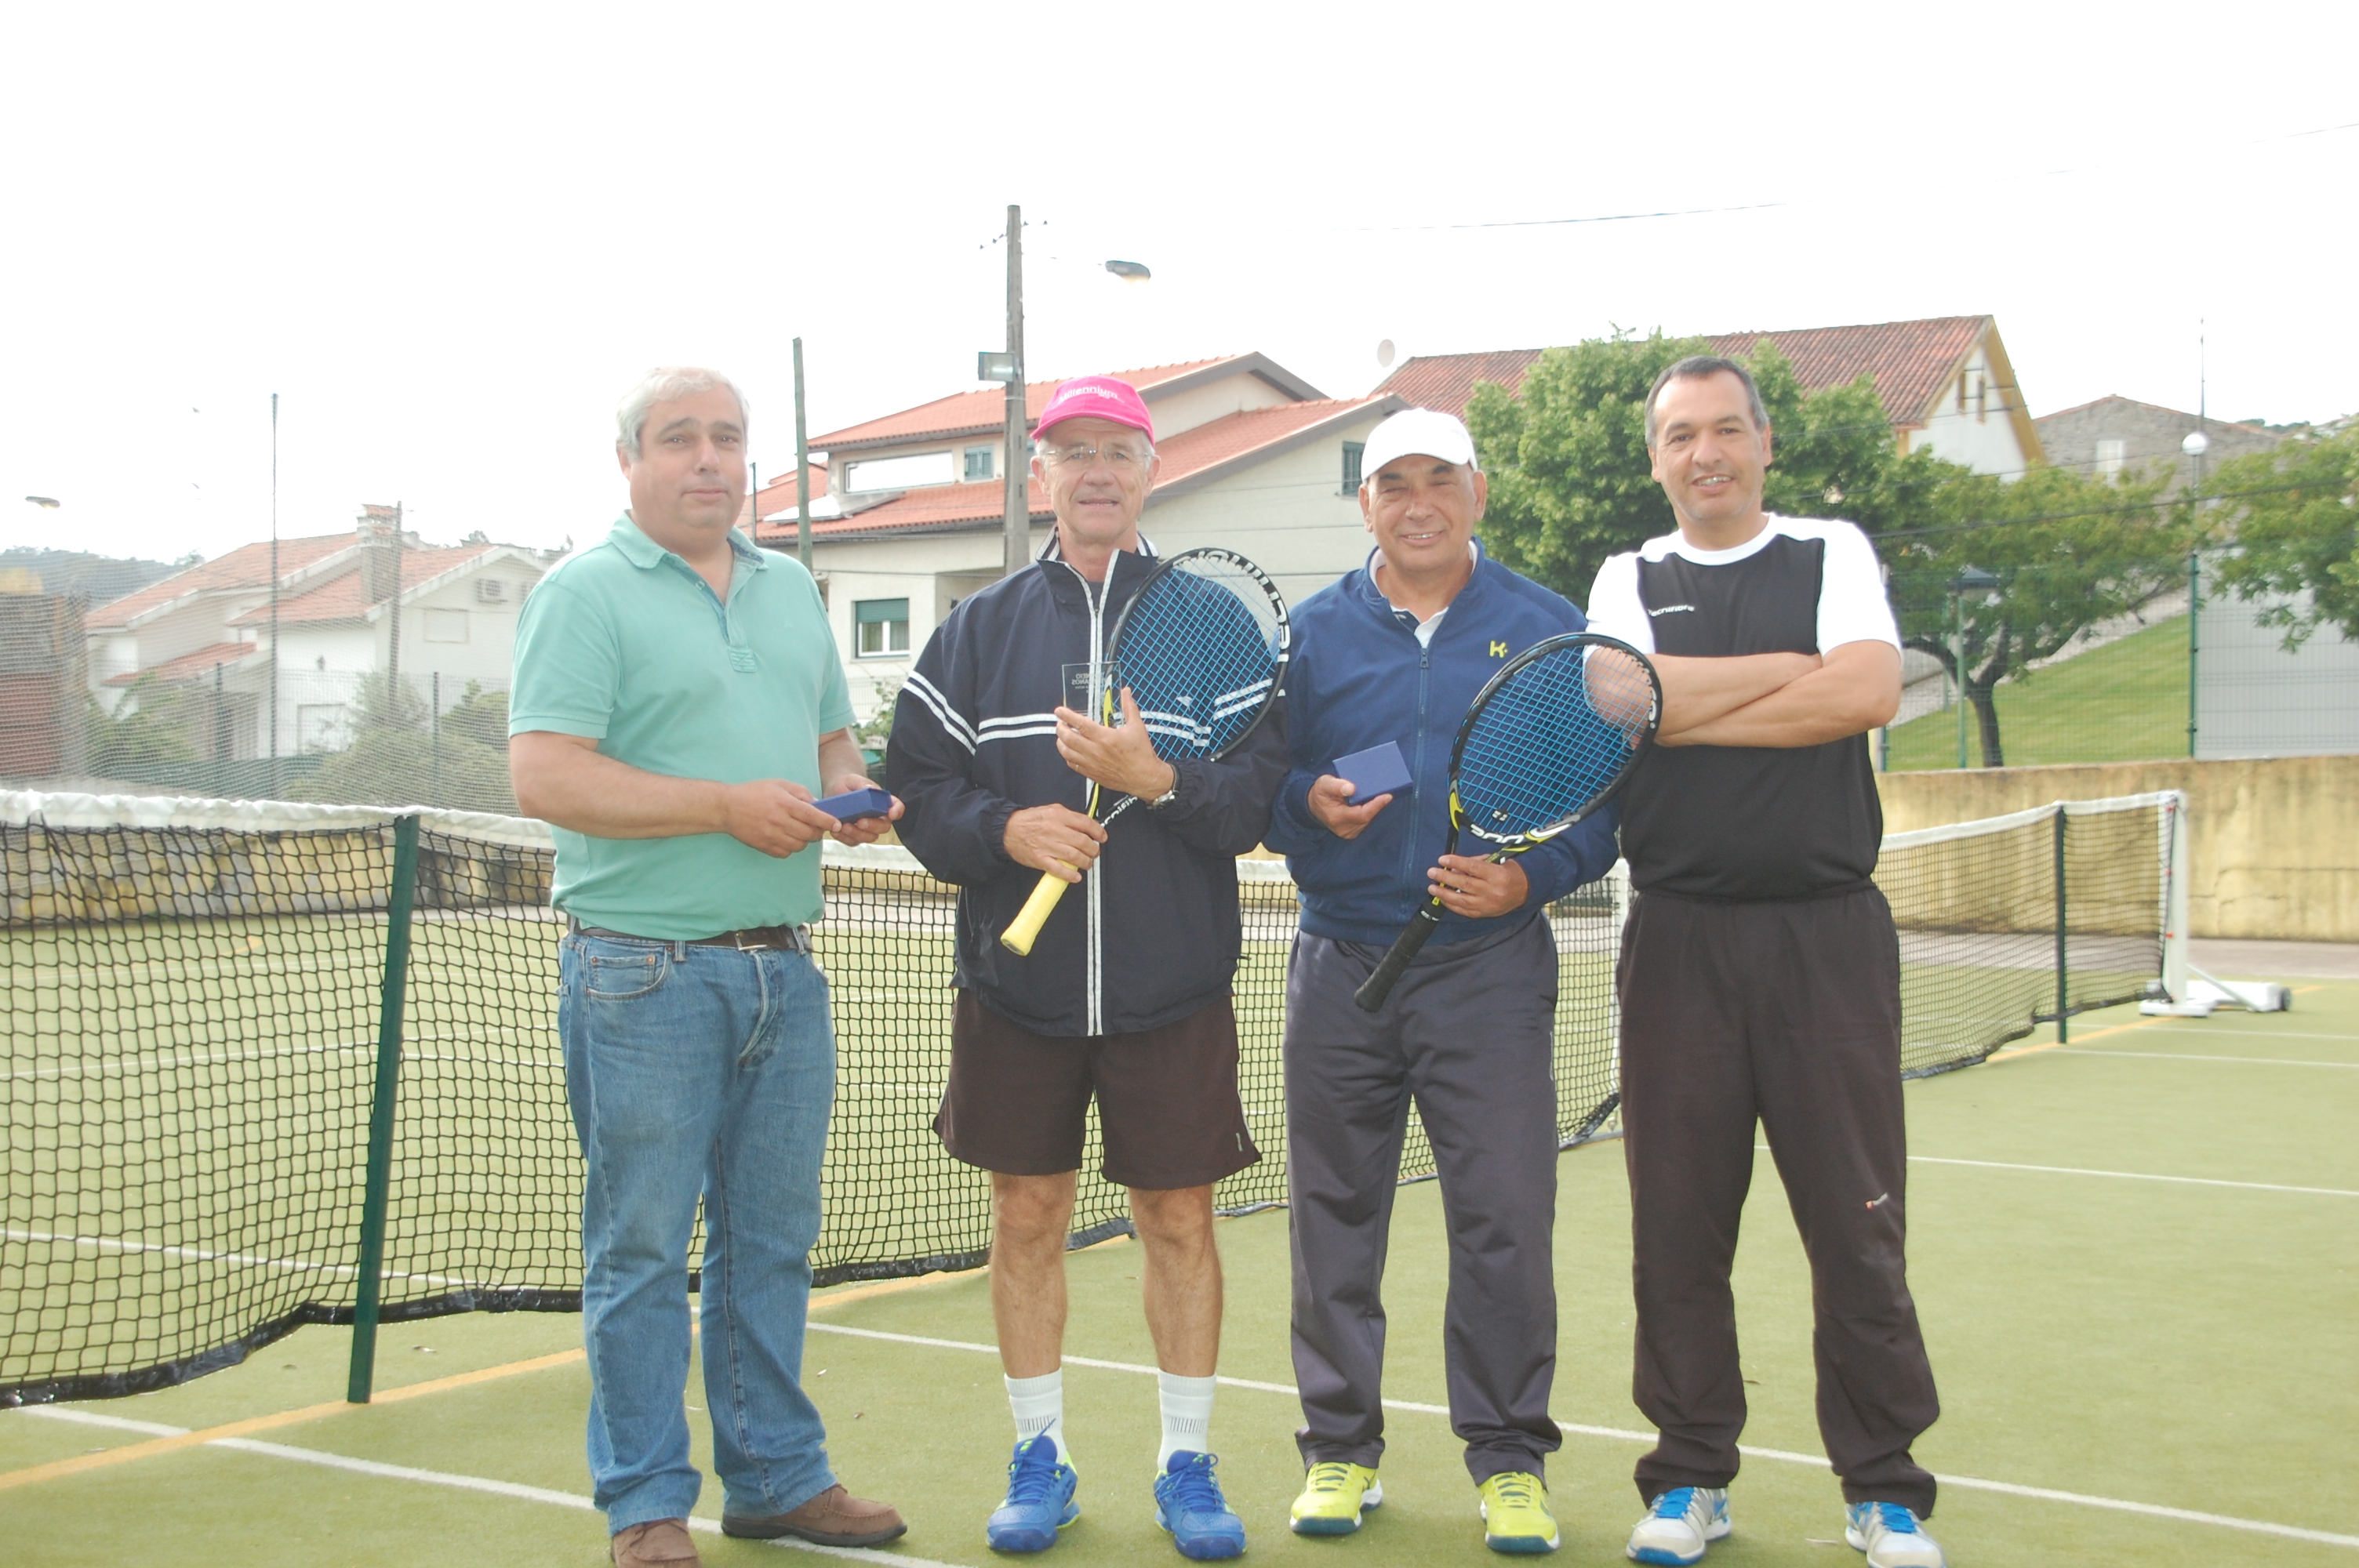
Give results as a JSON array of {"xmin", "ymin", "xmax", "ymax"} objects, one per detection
[{"xmin": 0, "ymin": 795, "xmax": 2177, "ymax": 1405}]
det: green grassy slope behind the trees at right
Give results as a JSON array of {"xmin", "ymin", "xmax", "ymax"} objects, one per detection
[{"xmin": 1892, "ymin": 615, "xmax": 2186, "ymax": 773}]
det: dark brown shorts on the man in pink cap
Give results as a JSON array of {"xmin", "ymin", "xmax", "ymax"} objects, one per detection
[{"xmin": 934, "ymin": 990, "xmax": 1262, "ymax": 1191}]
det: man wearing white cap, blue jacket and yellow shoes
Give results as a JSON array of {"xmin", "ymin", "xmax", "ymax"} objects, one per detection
[{"xmin": 1269, "ymin": 408, "xmax": 1618, "ymax": 1552}]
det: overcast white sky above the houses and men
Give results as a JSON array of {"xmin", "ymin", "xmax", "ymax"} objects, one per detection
[{"xmin": 0, "ymin": 0, "xmax": 2359, "ymax": 557}]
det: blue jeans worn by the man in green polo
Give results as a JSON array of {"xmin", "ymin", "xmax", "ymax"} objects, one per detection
[{"xmin": 557, "ymin": 934, "xmax": 835, "ymax": 1530}]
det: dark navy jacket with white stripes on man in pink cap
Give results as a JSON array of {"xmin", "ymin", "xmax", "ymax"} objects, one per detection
[{"xmin": 885, "ymin": 535, "xmax": 1285, "ymax": 1035}]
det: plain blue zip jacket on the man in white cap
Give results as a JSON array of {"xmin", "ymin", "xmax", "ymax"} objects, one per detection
[{"xmin": 1269, "ymin": 547, "xmax": 1620, "ymax": 946}]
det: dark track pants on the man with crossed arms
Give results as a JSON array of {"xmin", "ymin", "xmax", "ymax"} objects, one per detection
[{"xmin": 1616, "ymin": 887, "xmax": 1942, "ymax": 1516}]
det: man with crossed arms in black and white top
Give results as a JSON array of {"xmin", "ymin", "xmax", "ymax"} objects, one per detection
[{"xmin": 1590, "ymin": 358, "xmax": 1942, "ymax": 1568}]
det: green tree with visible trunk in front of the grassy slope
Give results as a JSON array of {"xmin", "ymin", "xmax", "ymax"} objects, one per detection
[{"xmin": 1882, "ymin": 466, "xmax": 2191, "ymax": 768}]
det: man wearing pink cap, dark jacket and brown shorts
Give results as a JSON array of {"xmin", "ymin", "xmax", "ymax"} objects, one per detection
[{"xmin": 885, "ymin": 375, "xmax": 1285, "ymax": 1559}]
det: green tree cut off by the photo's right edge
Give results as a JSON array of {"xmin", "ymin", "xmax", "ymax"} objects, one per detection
[{"xmin": 2205, "ymin": 424, "xmax": 2359, "ymax": 653}]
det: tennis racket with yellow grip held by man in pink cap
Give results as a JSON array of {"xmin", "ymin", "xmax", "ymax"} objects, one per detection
[{"xmin": 1000, "ymin": 547, "xmax": 1290, "ymax": 955}]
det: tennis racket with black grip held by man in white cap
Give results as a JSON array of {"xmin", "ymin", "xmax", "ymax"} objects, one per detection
[{"xmin": 1352, "ymin": 632, "xmax": 1663, "ymax": 1011}]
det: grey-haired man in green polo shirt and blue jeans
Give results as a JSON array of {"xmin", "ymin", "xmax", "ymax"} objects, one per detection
[{"xmin": 507, "ymin": 368, "xmax": 906, "ymax": 1568}]
